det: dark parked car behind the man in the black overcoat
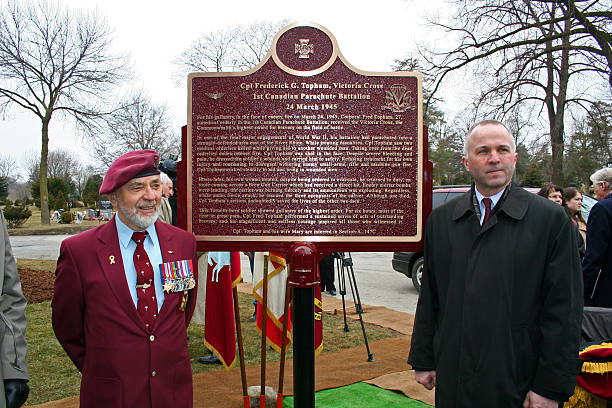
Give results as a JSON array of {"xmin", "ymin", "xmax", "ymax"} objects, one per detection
[{"xmin": 391, "ymin": 185, "xmax": 597, "ymax": 292}]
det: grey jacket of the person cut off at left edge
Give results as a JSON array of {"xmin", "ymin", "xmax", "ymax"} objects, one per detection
[{"xmin": 0, "ymin": 211, "xmax": 28, "ymax": 408}]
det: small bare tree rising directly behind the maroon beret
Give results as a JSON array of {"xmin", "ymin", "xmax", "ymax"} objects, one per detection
[{"xmin": 92, "ymin": 92, "xmax": 181, "ymax": 168}]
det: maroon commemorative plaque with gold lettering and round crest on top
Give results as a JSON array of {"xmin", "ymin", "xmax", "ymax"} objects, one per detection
[{"xmin": 185, "ymin": 24, "xmax": 426, "ymax": 251}]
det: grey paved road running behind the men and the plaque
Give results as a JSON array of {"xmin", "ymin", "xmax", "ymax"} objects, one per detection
[{"xmin": 10, "ymin": 235, "xmax": 418, "ymax": 313}]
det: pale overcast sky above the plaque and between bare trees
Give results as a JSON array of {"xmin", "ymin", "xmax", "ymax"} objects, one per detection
[{"xmin": 0, "ymin": 0, "xmax": 454, "ymax": 178}]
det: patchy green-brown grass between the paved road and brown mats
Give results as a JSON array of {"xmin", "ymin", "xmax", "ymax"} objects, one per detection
[{"xmin": 18, "ymin": 294, "xmax": 401, "ymax": 405}]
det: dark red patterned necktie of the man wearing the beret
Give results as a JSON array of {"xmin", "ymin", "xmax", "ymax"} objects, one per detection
[{"xmin": 132, "ymin": 231, "xmax": 157, "ymax": 330}]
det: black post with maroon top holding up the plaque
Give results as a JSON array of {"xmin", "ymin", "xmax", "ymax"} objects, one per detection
[{"xmin": 289, "ymin": 243, "xmax": 319, "ymax": 408}]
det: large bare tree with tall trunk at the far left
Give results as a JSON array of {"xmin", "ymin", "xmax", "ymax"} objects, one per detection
[{"xmin": 0, "ymin": 0, "xmax": 127, "ymax": 224}]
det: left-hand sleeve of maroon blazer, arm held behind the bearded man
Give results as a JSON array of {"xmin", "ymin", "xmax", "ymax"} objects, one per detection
[{"xmin": 51, "ymin": 241, "xmax": 85, "ymax": 371}]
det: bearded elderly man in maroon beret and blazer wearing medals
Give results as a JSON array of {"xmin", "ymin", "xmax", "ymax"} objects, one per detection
[{"xmin": 52, "ymin": 150, "xmax": 197, "ymax": 408}]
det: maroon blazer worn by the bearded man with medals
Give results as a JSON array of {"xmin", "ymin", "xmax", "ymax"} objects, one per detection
[{"xmin": 51, "ymin": 218, "xmax": 197, "ymax": 408}]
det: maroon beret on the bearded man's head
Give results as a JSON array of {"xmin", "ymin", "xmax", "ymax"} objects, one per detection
[{"xmin": 100, "ymin": 150, "xmax": 159, "ymax": 194}]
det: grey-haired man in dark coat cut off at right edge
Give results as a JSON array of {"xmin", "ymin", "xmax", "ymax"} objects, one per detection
[{"xmin": 582, "ymin": 168, "xmax": 612, "ymax": 308}]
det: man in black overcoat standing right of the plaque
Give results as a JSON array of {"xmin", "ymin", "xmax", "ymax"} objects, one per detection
[{"xmin": 408, "ymin": 121, "xmax": 582, "ymax": 408}]
